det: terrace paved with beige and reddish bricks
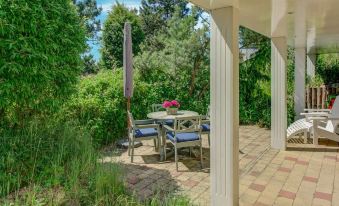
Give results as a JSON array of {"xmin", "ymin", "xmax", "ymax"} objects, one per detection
[{"xmin": 104, "ymin": 126, "xmax": 339, "ymax": 206}]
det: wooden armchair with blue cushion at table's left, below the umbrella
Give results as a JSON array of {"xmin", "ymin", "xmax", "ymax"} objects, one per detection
[{"xmin": 128, "ymin": 112, "xmax": 161, "ymax": 162}]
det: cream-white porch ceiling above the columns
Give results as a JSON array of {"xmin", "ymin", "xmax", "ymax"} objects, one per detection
[{"xmin": 190, "ymin": 0, "xmax": 339, "ymax": 53}]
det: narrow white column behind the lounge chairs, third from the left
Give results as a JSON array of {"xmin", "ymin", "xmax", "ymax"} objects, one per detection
[{"xmin": 294, "ymin": 48, "xmax": 306, "ymax": 120}]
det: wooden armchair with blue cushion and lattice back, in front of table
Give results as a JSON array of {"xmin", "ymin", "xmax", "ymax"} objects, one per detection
[{"xmin": 164, "ymin": 116, "xmax": 203, "ymax": 171}]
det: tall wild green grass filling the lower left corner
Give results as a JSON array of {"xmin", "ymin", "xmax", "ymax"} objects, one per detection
[{"xmin": 0, "ymin": 120, "xmax": 193, "ymax": 206}]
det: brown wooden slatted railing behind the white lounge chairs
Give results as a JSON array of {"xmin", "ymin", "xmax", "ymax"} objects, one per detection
[{"xmin": 305, "ymin": 84, "xmax": 339, "ymax": 109}]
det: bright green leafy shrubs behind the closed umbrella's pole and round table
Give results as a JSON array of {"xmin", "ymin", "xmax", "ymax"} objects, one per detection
[{"xmin": 60, "ymin": 66, "xmax": 207, "ymax": 146}]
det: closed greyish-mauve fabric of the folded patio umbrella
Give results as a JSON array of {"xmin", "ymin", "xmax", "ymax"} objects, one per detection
[{"xmin": 124, "ymin": 22, "xmax": 133, "ymax": 98}]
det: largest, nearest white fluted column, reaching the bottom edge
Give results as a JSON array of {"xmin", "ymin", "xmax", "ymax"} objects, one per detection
[{"xmin": 211, "ymin": 7, "xmax": 239, "ymax": 206}]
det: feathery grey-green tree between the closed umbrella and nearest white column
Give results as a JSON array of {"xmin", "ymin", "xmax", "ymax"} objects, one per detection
[{"xmin": 135, "ymin": 7, "xmax": 209, "ymax": 112}]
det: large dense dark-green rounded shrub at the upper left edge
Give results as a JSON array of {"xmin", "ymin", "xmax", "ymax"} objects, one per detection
[{"xmin": 0, "ymin": 0, "xmax": 85, "ymax": 124}]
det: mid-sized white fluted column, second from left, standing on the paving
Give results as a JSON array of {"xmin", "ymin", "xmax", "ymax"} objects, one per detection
[{"xmin": 271, "ymin": 37, "xmax": 287, "ymax": 150}]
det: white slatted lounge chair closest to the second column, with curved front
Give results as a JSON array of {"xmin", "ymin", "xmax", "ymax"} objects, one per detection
[{"xmin": 287, "ymin": 96, "xmax": 339, "ymax": 143}]
